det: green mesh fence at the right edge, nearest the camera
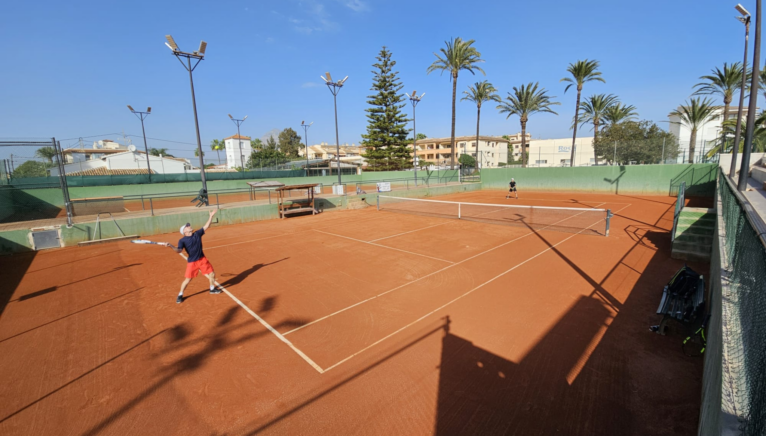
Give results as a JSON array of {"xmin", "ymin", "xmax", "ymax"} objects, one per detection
[{"xmin": 712, "ymin": 169, "xmax": 766, "ymax": 436}]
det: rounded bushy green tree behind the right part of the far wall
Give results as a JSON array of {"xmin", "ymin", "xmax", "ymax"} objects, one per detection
[{"xmin": 593, "ymin": 121, "xmax": 678, "ymax": 165}]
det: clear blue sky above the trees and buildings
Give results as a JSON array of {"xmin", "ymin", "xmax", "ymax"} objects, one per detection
[{"xmin": 0, "ymin": 0, "xmax": 755, "ymax": 162}]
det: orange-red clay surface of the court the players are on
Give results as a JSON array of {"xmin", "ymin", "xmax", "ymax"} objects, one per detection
[{"xmin": 0, "ymin": 191, "xmax": 708, "ymax": 436}]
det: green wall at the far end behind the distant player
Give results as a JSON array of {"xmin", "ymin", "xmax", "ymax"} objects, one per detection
[{"xmin": 481, "ymin": 164, "xmax": 718, "ymax": 197}]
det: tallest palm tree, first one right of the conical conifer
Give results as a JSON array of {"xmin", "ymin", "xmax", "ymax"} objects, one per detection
[{"xmin": 426, "ymin": 37, "xmax": 487, "ymax": 168}]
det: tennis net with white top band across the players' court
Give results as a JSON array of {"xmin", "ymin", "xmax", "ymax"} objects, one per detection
[{"xmin": 378, "ymin": 195, "xmax": 610, "ymax": 236}]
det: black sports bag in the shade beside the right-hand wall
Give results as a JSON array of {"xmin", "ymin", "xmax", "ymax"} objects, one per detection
[{"xmin": 651, "ymin": 266, "xmax": 705, "ymax": 335}]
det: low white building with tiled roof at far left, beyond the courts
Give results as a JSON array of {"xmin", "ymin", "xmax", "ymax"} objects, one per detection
[{"xmin": 50, "ymin": 151, "xmax": 194, "ymax": 176}]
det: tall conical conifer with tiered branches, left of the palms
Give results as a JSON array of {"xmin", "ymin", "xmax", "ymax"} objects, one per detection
[{"xmin": 362, "ymin": 46, "xmax": 412, "ymax": 171}]
